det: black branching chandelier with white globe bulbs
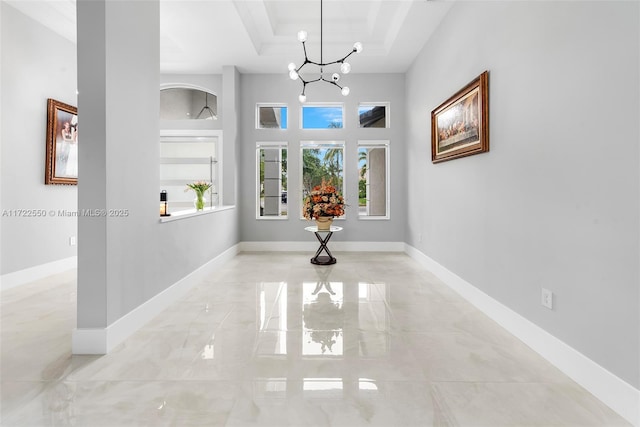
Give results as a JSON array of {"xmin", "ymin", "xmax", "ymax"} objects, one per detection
[{"xmin": 289, "ymin": 0, "xmax": 362, "ymax": 102}]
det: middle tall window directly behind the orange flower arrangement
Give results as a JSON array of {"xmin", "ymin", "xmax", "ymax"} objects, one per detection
[{"xmin": 300, "ymin": 141, "xmax": 345, "ymax": 219}]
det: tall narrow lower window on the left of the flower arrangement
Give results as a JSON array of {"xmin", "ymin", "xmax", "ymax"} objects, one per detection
[{"xmin": 256, "ymin": 142, "xmax": 289, "ymax": 218}]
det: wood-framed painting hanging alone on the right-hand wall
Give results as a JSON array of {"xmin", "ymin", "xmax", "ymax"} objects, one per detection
[{"xmin": 431, "ymin": 71, "xmax": 489, "ymax": 163}]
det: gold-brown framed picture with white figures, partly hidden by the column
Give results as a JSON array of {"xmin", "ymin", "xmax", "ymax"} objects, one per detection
[{"xmin": 44, "ymin": 99, "xmax": 78, "ymax": 185}]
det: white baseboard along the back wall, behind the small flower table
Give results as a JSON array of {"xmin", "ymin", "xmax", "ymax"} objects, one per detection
[{"xmin": 240, "ymin": 241, "xmax": 405, "ymax": 252}]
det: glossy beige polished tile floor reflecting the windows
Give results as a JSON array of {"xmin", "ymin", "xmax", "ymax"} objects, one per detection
[{"xmin": 0, "ymin": 253, "xmax": 628, "ymax": 427}]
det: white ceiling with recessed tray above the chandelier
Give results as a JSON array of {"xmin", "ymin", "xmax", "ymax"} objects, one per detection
[{"xmin": 5, "ymin": 0, "xmax": 452, "ymax": 74}]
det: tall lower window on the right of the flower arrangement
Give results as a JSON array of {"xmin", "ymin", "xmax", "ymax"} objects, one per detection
[{"xmin": 358, "ymin": 141, "xmax": 390, "ymax": 219}]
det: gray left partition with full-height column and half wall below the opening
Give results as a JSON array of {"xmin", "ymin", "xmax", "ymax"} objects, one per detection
[{"xmin": 77, "ymin": 0, "xmax": 238, "ymax": 329}]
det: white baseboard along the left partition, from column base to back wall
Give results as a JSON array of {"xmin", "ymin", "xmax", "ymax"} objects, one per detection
[{"xmin": 71, "ymin": 245, "xmax": 239, "ymax": 354}]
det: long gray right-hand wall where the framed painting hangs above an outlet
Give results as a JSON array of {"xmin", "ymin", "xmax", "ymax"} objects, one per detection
[{"xmin": 405, "ymin": 2, "xmax": 640, "ymax": 388}]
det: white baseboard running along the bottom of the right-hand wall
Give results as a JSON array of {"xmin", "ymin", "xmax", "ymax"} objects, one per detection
[{"xmin": 405, "ymin": 245, "xmax": 640, "ymax": 426}]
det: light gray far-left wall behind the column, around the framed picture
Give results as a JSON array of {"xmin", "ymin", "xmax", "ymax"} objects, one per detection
[{"xmin": 0, "ymin": 2, "xmax": 77, "ymax": 274}]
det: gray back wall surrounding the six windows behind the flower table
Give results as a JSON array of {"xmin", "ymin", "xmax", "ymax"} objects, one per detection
[{"xmin": 240, "ymin": 72, "xmax": 406, "ymax": 242}]
